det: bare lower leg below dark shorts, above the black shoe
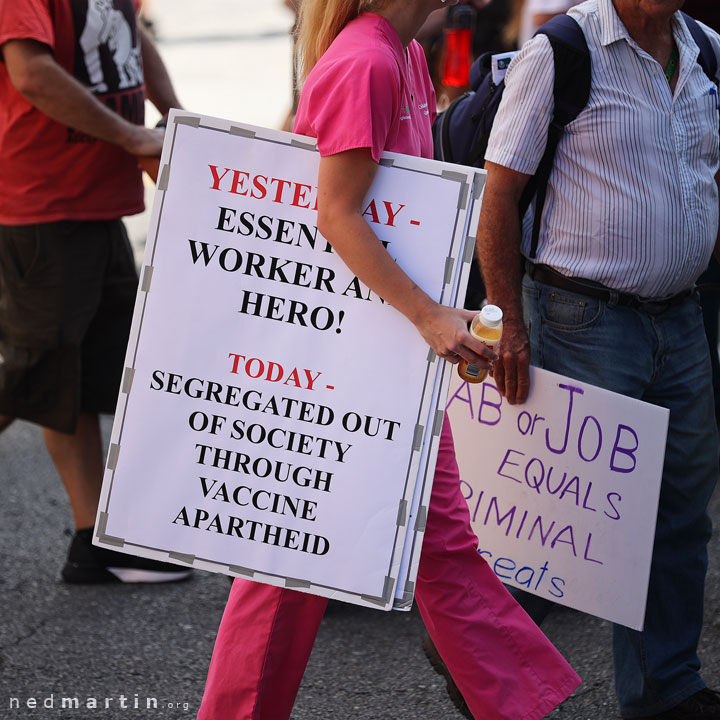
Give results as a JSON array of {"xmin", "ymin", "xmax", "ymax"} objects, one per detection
[{"xmin": 43, "ymin": 413, "xmax": 103, "ymax": 530}]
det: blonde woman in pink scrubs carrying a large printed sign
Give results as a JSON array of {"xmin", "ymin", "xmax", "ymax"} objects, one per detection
[{"xmin": 198, "ymin": 0, "xmax": 580, "ymax": 720}]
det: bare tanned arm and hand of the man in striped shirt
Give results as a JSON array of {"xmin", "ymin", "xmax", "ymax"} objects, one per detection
[{"xmin": 477, "ymin": 162, "xmax": 530, "ymax": 405}]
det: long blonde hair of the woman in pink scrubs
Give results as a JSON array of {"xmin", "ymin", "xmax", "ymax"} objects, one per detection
[{"xmin": 295, "ymin": 0, "xmax": 382, "ymax": 83}]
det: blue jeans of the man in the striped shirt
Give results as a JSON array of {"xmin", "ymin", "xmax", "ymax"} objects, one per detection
[{"xmin": 513, "ymin": 276, "xmax": 718, "ymax": 718}]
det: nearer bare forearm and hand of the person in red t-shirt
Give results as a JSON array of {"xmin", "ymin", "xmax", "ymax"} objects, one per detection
[{"xmin": 0, "ymin": 40, "xmax": 163, "ymax": 155}]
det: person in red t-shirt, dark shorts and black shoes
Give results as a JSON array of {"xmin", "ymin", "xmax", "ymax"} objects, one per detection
[{"xmin": 0, "ymin": 0, "xmax": 189, "ymax": 583}]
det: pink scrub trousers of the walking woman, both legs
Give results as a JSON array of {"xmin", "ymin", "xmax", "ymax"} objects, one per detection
[{"xmin": 197, "ymin": 417, "xmax": 580, "ymax": 720}]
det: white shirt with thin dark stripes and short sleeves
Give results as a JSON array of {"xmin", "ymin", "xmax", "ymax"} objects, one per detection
[{"xmin": 486, "ymin": 0, "xmax": 720, "ymax": 298}]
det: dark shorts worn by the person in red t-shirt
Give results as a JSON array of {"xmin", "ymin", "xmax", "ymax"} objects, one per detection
[{"xmin": 0, "ymin": 220, "xmax": 137, "ymax": 433}]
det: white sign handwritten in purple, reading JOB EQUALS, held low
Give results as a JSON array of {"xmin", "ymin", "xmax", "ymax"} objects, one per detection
[{"xmin": 448, "ymin": 368, "xmax": 669, "ymax": 629}]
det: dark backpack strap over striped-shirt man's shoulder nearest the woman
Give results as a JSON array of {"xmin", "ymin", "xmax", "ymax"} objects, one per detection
[{"xmin": 520, "ymin": 15, "xmax": 591, "ymax": 259}]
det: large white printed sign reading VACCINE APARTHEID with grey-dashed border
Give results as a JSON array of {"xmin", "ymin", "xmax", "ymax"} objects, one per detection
[{"xmin": 96, "ymin": 113, "xmax": 480, "ymax": 609}]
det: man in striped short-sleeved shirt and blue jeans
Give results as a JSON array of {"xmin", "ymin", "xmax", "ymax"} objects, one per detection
[{"xmin": 478, "ymin": 0, "xmax": 720, "ymax": 720}]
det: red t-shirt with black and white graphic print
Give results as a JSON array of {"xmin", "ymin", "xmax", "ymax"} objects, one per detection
[{"xmin": 0, "ymin": 0, "xmax": 145, "ymax": 224}]
